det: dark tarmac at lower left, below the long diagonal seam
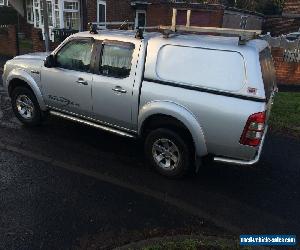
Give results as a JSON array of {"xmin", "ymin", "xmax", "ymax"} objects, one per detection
[{"xmin": 0, "ymin": 150, "xmax": 220, "ymax": 250}]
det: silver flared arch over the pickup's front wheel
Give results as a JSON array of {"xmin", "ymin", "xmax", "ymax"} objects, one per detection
[{"xmin": 7, "ymin": 70, "xmax": 47, "ymax": 111}]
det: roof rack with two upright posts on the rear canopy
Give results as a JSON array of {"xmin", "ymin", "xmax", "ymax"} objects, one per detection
[{"xmin": 145, "ymin": 8, "xmax": 262, "ymax": 44}]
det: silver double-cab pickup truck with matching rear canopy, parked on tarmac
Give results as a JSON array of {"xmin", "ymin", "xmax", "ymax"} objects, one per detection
[{"xmin": 3, "ymin": 31, "xmax": 276, "ymax": 177}]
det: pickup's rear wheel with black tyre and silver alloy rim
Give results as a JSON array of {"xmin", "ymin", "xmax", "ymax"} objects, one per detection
[{"xmin": 145, "ymin": 128, "xmax": 193, "ymax": 178}]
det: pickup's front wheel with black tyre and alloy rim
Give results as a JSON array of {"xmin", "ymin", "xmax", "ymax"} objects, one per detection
[{"xmin": 11, "ymin": 87, "xmax": 42, "ymax": 127}]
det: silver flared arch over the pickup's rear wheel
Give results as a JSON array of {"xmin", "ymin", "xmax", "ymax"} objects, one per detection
[{"xmin": 138, "ymin": 101, "xmax": 207, "ymax": 157}]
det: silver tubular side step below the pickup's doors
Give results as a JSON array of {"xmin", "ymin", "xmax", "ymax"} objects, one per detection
[{"xmin": 50, "ymin": 111, "xmax": 135, "ymax": 138}]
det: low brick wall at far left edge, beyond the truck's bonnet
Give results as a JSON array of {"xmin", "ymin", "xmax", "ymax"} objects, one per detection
[{"xmin": 0, "ymin": 25, "xmax": 17, "ymax": 56}]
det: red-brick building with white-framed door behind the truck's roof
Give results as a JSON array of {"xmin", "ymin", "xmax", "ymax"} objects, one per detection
[{"xmin": 86, "ymin": 0, "xmax": 224, "ymax": 27}]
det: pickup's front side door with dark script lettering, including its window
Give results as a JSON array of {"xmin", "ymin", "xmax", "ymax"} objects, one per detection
[{"xmin": 42, "ymin": 38, "xmax": 93, "ymax": 116}]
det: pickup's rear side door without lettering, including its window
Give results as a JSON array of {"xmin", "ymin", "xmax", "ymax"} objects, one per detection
[{"xmin": 92, "ymin": 41, "xmax": 138, "ymax": 129}]
